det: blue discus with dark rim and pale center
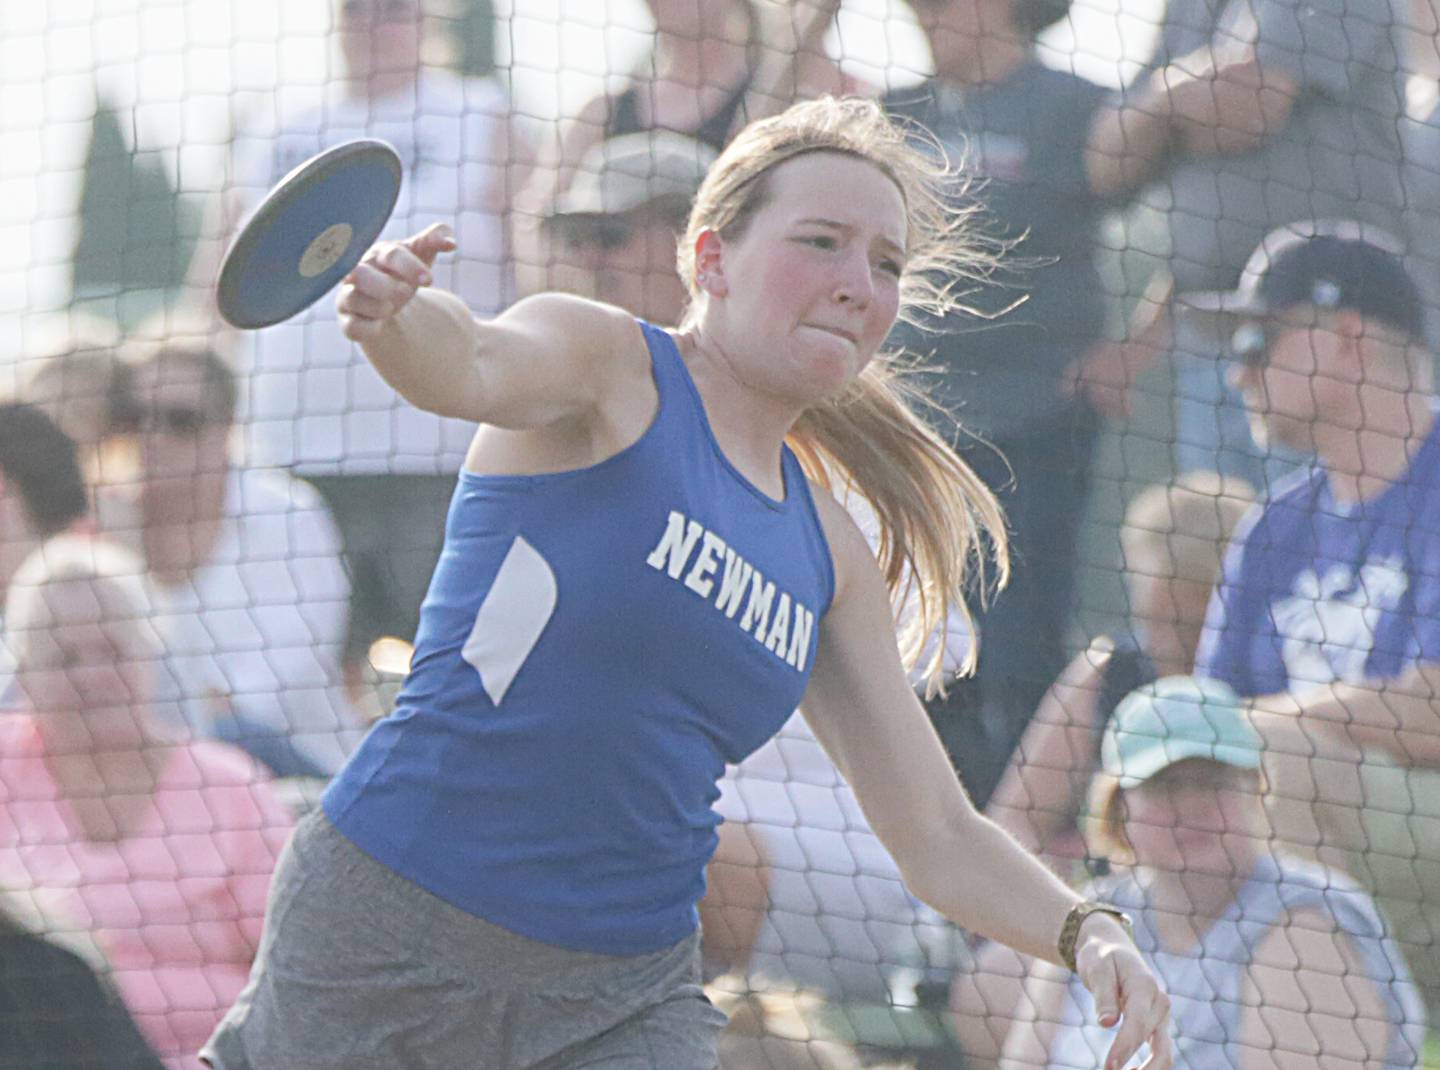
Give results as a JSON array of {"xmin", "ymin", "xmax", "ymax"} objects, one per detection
[{"xmin": 216, "ymin": 138, "xmax": 403, "ymax": 330}]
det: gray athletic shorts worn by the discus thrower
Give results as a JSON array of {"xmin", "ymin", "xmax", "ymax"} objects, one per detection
[{"xmin": 202, "ymin": 811, "xmax": 726, "ymax": 1070}]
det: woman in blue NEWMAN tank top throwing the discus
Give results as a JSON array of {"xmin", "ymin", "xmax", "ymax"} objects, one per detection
[{"xmin": 207, "ymin": 99, "xmax": 1169, "ymax": 1070}]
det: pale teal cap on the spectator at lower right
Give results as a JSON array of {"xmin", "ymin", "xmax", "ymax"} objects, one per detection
[{"xmin": 1100, "ymin": 677, "xmax": 1260, "ymax": 789}]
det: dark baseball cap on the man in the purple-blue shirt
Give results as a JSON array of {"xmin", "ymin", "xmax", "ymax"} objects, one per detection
[{"xmin": 1176, "ymin": 220, "xmax": 1424, "ymax": 338}]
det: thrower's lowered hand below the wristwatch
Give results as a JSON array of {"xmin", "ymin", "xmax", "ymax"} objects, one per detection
[{"xmin": 1076, "ymin": 919, "xmax": 1175, "ymax": 1070}]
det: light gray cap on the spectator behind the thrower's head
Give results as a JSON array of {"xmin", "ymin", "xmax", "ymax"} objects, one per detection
[{"xmin": 549, "ymin": 130, "xmax": 716, "ymax": 217}]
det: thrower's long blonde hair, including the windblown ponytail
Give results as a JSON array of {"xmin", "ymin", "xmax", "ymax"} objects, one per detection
[{"xmin": 678, "ymin": 96, "xmax": 1009, "ymax": 693}]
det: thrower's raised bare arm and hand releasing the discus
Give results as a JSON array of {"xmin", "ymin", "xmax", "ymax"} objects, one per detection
[{"xmin": 336, "ymin": 225, "xmax": 635, "ymax": 431}]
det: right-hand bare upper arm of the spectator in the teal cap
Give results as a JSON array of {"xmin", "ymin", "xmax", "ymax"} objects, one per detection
[{"xmin": 1237, "ymin": 910, "xmax": 1395, "ymax": 1070}]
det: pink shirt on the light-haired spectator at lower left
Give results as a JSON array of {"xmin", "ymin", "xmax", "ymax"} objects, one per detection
[{"xmin": 0, "ymin": 713, "xmax": 294, "ymax": 1070}]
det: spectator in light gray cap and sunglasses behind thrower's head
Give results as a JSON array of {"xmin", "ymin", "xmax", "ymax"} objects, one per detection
[{"xmin": 544, "ymin": 130, "xmax": 716, "ymax": 327}]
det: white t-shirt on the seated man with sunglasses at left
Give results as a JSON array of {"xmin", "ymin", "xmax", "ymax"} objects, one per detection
[{"xmin": 142, "ymin": 469, "xmax": 363, "ymax": 770}]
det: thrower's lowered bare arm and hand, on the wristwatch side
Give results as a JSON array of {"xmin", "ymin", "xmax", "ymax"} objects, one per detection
[{"xmin": 802, "ymin": 494, "xmax": 1171, "ymax": 1070}]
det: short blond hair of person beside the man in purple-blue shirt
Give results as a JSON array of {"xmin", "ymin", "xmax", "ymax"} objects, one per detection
[{"xmin": 1120, "ymin": 472, "xmax": 1256, "ymax": 583}]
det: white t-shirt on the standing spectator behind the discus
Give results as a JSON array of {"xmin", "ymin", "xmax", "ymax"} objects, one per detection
[{"xmin": 233, "ymin": 72, "xmax": 510, "ymax": 475}]
